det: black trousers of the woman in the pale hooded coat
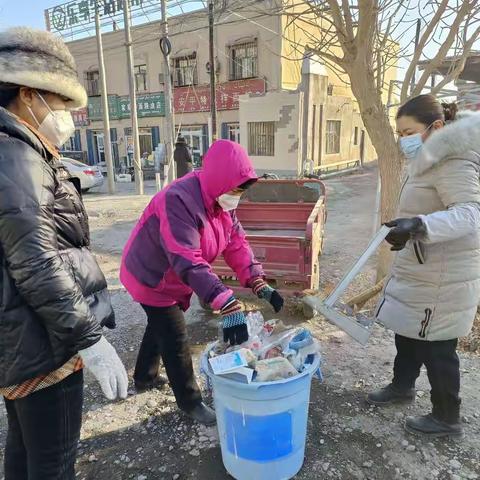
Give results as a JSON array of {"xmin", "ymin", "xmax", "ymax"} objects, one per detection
[{"xmin": 393, "ymin": 335, "xmax": 461, "ymax": 423}]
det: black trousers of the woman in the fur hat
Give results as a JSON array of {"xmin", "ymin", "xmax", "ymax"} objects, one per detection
[{"xmin": 5, "ymin": 371, "xmax": 83, "ymax": 480}]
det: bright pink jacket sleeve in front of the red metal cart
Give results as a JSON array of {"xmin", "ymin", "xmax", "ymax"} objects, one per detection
[{"xmin": 223, "ymin": 212, "xmax": 265, "ymax": 287}]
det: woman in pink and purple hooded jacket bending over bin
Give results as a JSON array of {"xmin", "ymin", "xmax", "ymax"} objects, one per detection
[{"xmin": 120, "ymin": 140, "xmax": 283, "ymax": 424}]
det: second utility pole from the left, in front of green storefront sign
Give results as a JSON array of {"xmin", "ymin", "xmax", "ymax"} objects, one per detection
[{"xmin": 123, "ymin": 0, "xmax": 144, "ymax": 195}]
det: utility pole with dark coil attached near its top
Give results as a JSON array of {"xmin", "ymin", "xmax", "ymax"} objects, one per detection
[{"xmin": 157, "ymin": 0, "xmax": 176, "ymax": 185}]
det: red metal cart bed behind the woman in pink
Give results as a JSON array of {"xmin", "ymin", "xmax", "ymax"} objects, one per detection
[{"xmin": 214, "ymin": 179, "xmax": 326, "ymax": 294}]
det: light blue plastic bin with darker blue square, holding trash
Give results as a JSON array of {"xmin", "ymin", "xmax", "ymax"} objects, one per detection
[{"xmin": 202, "ymin": 349, "xmax": 320, "ymax": 480}]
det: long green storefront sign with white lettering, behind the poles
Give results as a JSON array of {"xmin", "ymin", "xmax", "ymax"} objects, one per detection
[{"xmin": 88, "ymin": 92, "xmax": 165, "ymax": 121}]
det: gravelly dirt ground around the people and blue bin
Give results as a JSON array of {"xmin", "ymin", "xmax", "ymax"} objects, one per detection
[{"xmin": 0, "ymin": 170, "xmax": 480, "ymax": 480}]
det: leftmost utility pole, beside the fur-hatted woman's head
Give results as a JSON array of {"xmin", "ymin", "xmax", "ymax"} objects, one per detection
[{"xmin": 95, "ymin": 2, "xmax": 115, "ymax": 195}]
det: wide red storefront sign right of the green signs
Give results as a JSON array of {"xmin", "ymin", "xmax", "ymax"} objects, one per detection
[{"xmin": 173, "ymin": 78, "xmax": 265, "ymax": 113}]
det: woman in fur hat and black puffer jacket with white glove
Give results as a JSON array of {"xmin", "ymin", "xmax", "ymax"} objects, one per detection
[{"xmin": 0, "ymin": 28, "xmax": 128, "ymax": 480}]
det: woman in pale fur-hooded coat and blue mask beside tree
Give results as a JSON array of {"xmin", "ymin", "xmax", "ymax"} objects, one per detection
[{"xmin": 367, "ymin": 95, "xmax": 480, "ymax": 437}]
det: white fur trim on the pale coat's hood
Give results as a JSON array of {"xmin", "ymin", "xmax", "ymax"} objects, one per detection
[{"xmin": 408, "ymin": 113, "xmax": 480, "ymax": 177}]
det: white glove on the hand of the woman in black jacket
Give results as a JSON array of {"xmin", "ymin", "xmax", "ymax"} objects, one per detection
[{"xmin": 78, "ymin": 337, "xmax": 128, "ymax": 400}]
